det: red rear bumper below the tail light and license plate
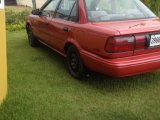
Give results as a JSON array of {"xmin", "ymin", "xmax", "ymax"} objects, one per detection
[{"xmin": 80, "ymin": 51, "xmax": 160, "ymax": 77}]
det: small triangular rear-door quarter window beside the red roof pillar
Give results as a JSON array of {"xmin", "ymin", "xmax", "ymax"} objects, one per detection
[{"xmin": 69, "ymin": 2, "xmax": 78, "ymax": 22}]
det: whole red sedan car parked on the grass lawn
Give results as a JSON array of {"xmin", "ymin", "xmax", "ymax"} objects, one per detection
[{"xmin": 26, "ymin": 0, "xmax": 160, "ymax": 78}]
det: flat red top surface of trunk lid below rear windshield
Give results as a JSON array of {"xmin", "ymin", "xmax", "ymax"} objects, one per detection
[{"xmin": 92, "ymin": 18, "xmax": 160, "ymax": 35}]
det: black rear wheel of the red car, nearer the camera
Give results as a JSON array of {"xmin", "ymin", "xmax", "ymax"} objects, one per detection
[{"xmin": 67, "ymin": 45, "xmax": 86, "ymax": 79}]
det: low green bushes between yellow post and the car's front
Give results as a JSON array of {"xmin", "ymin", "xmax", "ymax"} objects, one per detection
[{"xmin": 6, "ymin": 9, "xmax": 29, "ymax": 31}]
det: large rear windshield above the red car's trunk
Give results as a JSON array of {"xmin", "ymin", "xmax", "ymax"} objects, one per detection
[{"xmin": 85, "ymin": 0, "xmax": 156, "ymax": 22}]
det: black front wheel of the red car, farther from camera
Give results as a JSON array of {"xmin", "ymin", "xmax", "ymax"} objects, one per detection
[{"xmin": 27, "ymin": 26, "xmax": 39, "ymax": 47}]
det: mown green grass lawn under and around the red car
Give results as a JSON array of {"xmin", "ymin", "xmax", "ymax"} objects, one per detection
[{"xmin": 0, "ymin": 31, "xmax": 160, "ymax": 120}]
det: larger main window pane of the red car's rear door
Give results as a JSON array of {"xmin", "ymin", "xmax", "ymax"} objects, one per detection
[{"xmin": 56, "ymin": 0, "xmax": 75, "ymax": 20}]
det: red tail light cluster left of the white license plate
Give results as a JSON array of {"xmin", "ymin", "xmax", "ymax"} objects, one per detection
[{"xmin": 105, "ymin": 35, "xmax": 146, "ymax": 58}]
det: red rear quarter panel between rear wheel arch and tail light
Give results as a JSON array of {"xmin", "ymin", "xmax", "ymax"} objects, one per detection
[{"xmin": 77, "ymin": 24, "xmax": 120, "ymax": 57}]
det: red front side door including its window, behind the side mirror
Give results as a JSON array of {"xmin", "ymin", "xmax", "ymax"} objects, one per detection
[{"xmin": 36, "ymin": 0, "xmax": 60, "ymax": 45}]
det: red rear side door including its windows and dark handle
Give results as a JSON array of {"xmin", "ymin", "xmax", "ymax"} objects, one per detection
[{"xmin": 50, "ymin": 0, "xmax": 78, "ymax": 51}]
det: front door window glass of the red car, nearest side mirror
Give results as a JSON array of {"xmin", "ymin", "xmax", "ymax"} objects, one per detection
[{"xmin": 42, "ymin": 0, "xmax": 59, "ymax": 18}]
